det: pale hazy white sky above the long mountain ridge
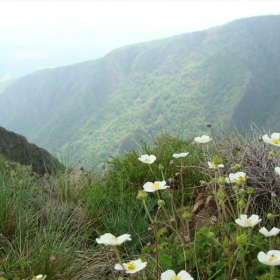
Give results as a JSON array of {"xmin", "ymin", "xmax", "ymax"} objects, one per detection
[{"xmin": 0, "ymin": 0, "xmax": 280, "ymax": 82}]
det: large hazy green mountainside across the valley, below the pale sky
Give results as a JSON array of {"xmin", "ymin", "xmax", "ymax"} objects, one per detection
[{"xmin": 0, "ymin": 16, "xmax": 280, "ymax": 167}]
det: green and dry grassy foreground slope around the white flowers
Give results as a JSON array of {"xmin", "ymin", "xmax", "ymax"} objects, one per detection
[{"xmin": 0, "ymin": 129, "xmax": 280, "ymax": 280}]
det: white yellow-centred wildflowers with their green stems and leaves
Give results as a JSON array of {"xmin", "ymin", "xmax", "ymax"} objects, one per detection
[{"xmin": 96, "ymin": 132, "xmax": 280, "ymax": 280}]
